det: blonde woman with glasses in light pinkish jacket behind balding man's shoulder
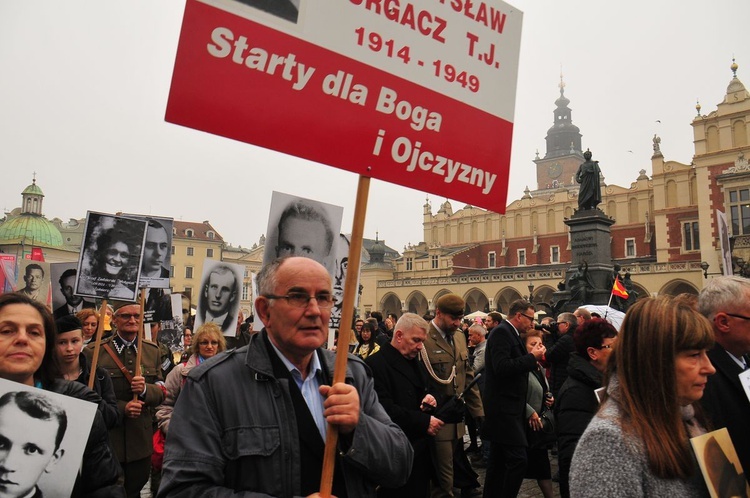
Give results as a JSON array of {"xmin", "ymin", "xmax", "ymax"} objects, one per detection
[{"xmin": 156, "ymin": 322, "xmax": 227, "ymax": 435}]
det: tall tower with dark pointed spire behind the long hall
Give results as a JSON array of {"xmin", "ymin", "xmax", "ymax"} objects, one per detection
[{"xmin": 534, "ymin": 75, "xmax": 584, "ymax": 190}]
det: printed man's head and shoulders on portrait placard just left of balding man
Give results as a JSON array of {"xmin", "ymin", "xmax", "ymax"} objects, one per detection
[{"xmin": 198, "ymin": 264, "xmax": 239, "ymax": 335}]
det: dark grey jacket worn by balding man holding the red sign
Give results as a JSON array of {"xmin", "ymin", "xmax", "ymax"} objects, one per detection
[{"xmin": 158, "ymin": 330, "xmax": 414, "ymax": 498}]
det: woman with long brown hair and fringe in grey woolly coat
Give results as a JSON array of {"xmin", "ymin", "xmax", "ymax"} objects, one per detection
[{"xmin": 570, "ymin": 296, "xmax": 716, "ymax": 498}]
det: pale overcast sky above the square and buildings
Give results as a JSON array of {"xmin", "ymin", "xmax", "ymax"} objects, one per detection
[{"xmin": 0, "ymin": 0, "xmax": 750, "ymax": 251}]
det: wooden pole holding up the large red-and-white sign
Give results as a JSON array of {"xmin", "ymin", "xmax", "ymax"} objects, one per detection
[{"xmin": 320, "ymin": 176, "xmax": 370, "ymax": 498}]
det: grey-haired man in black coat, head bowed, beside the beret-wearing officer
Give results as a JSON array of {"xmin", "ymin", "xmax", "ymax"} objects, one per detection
[{"xmin": 365, "ymin": 313, "xmax": 443, "ymax": 498}]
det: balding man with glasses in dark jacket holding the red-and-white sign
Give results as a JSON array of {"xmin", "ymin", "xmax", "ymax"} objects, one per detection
[{"xmin": 158, "ymin": 257, "xmax": 413, "ymax": 498}]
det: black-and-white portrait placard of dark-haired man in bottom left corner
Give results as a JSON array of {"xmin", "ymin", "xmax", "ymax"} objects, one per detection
[{"xmin": 0, "ymin": 379, "xmax": 96, "ymax": 498}]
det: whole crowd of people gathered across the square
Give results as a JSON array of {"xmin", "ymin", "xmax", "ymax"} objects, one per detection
[{"xmin": 0, "ymin": 257, "xmax": 750, "ymax": 498}]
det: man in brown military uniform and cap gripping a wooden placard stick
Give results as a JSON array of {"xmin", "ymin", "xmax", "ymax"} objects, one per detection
[{"xmin": 85, "ymin": 303, "xmax": 164, "ymax": 498}]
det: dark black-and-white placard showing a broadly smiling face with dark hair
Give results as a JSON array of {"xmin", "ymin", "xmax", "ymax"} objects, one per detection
[{"xmin": 75, "ymin": 211, "xmax": 148, "ymax": 301}]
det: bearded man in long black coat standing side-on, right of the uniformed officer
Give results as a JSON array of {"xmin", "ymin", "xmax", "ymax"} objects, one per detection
[{"xmin": 482, "ymin": 299, "xmax": 544, "ymax": 498}]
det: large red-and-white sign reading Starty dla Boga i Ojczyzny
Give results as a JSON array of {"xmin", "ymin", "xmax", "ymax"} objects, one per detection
[{"xmin": 166, "ymin": 0, "xmax": 522, "ymax": 212}]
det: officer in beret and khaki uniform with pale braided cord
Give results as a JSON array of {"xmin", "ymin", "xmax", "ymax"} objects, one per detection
[{"xmin": 424, "ymin": 294, "xmax": 484, "ymax": 498}]
